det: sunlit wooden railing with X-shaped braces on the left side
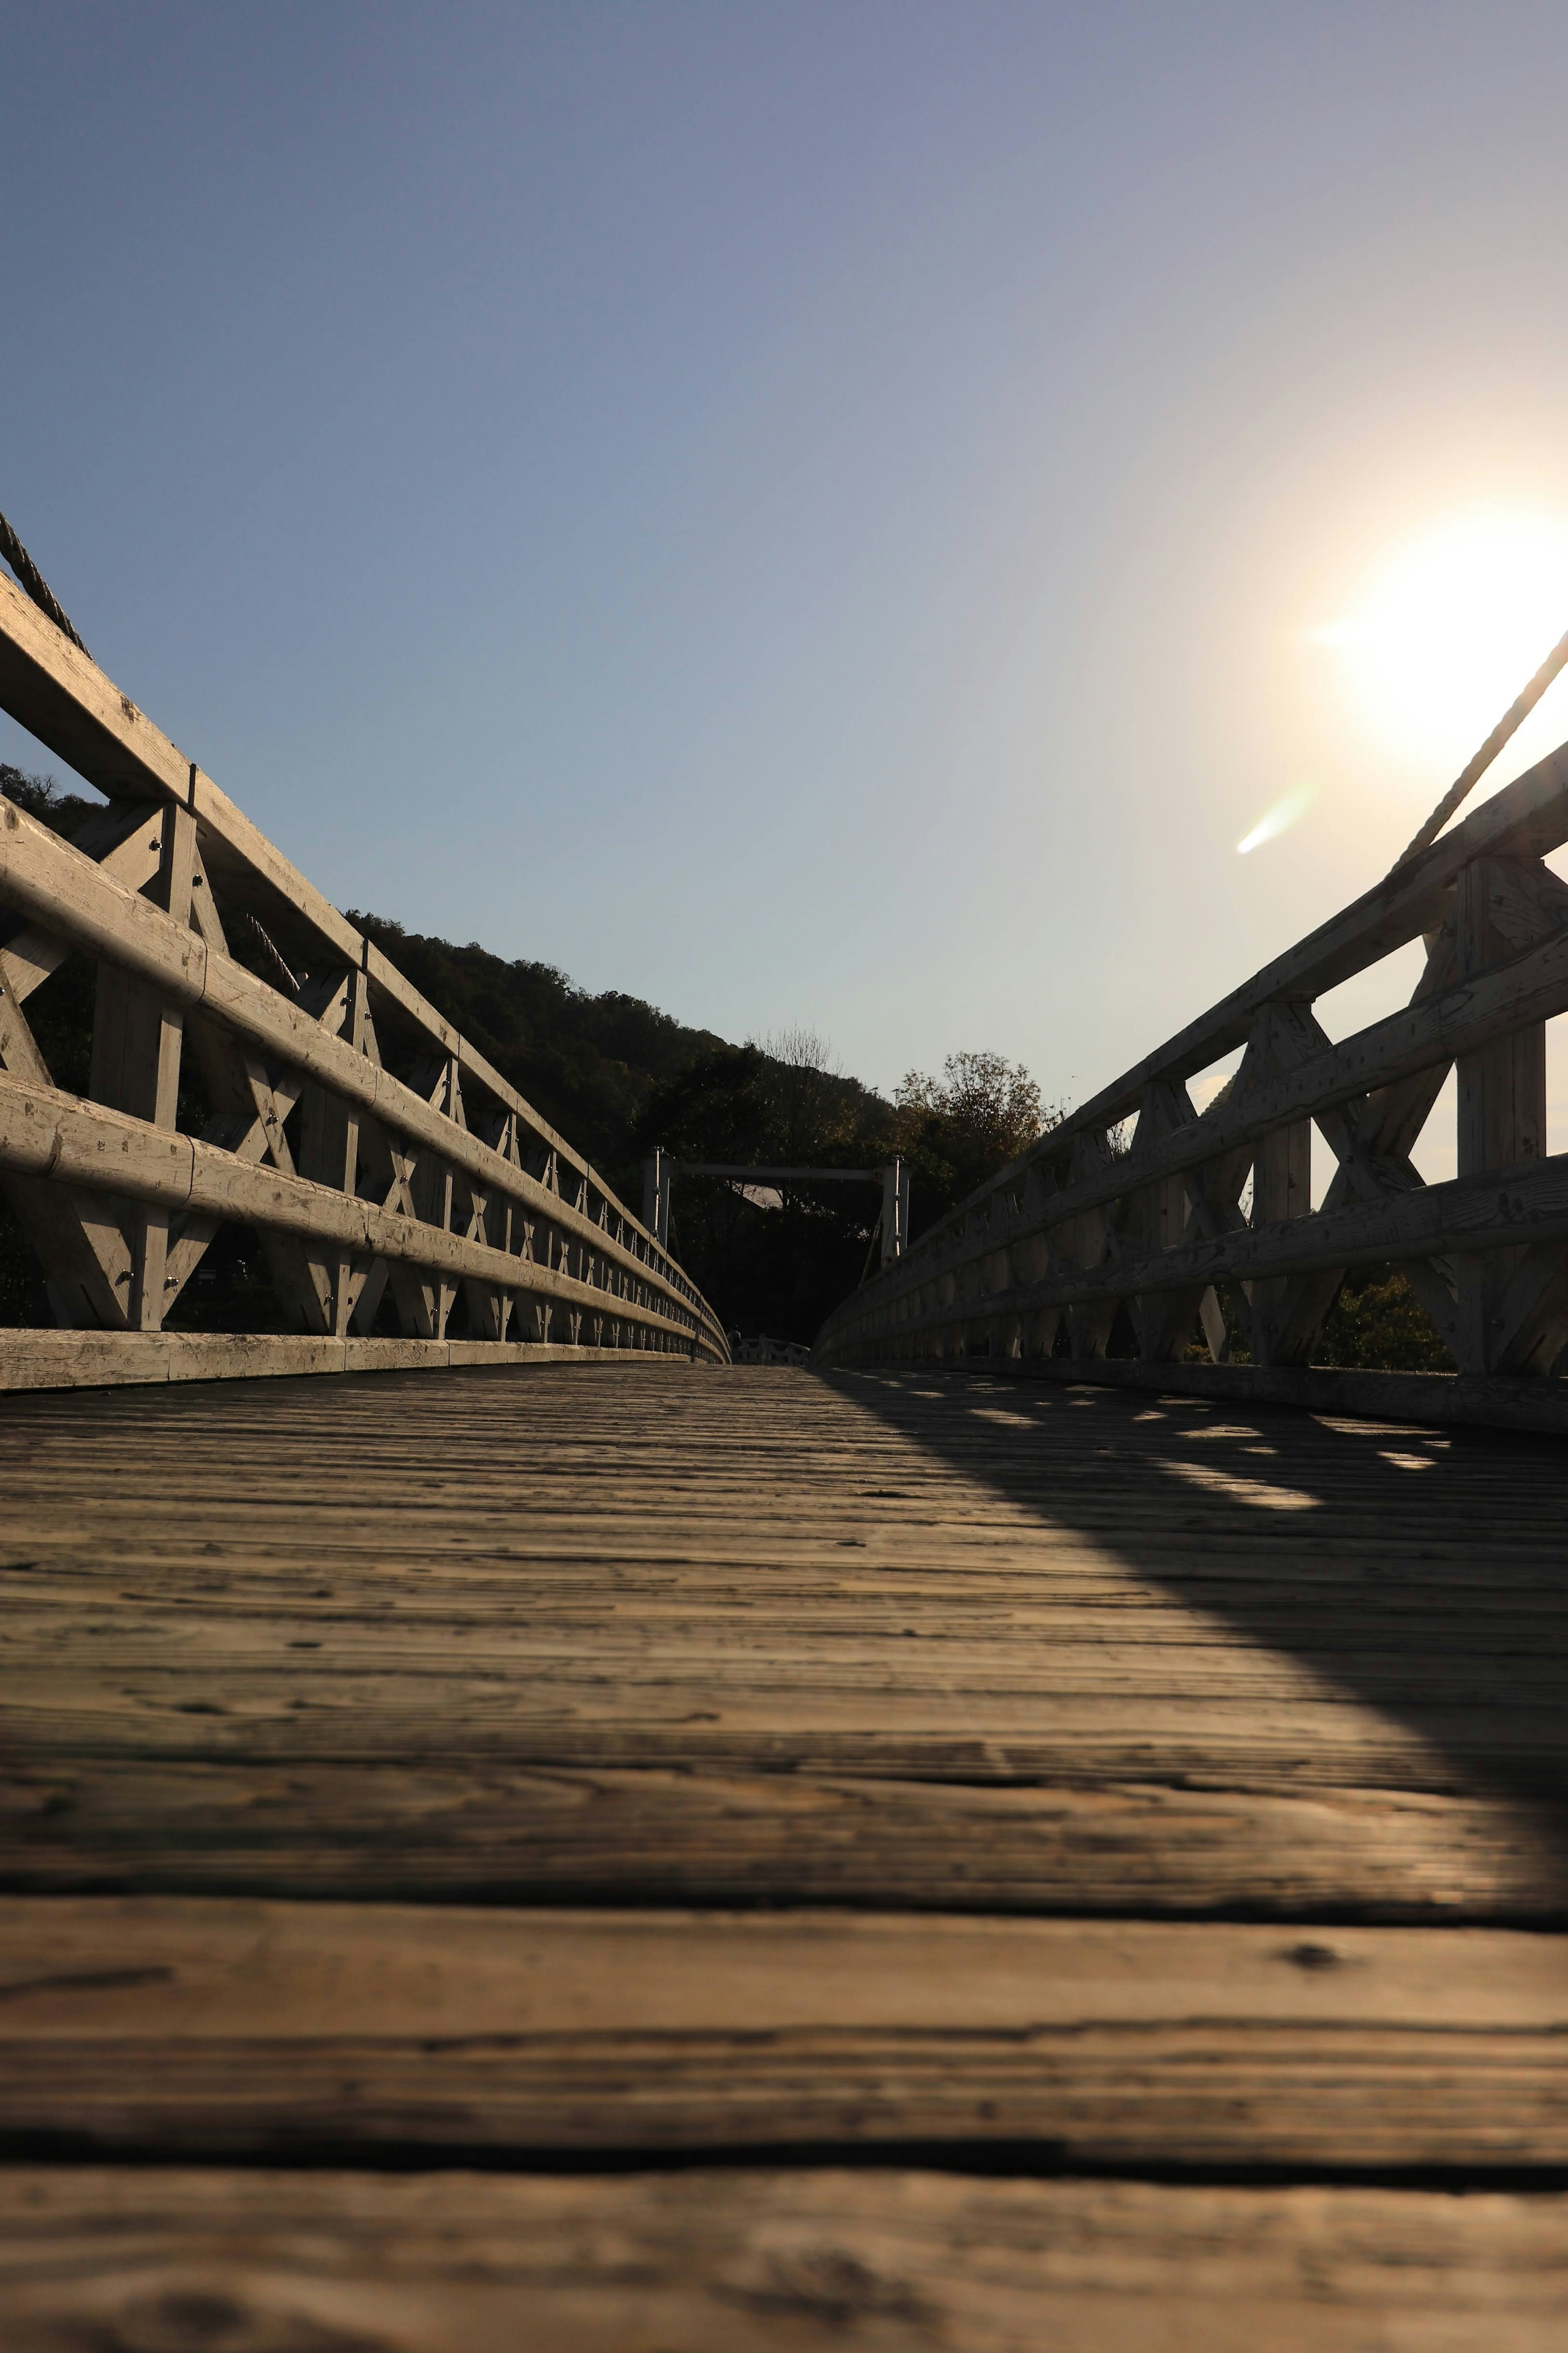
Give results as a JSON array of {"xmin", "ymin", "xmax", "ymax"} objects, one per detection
[{"xmin": 0, "ymin": 562, "xmax": 729, "ymax": 1386}]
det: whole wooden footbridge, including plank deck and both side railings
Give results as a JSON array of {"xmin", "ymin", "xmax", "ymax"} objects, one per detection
[{"xmin": 0, "ymin": 551, "xmax": 1568, "ymax": 2353}]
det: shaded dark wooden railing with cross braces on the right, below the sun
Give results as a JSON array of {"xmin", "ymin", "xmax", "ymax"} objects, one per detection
[{"xmin": 813, "ymin": 746, "xmax": 1568, "ymax": 1426}]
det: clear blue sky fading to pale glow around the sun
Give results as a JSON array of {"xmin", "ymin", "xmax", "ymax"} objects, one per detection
[{"xmin": 0, "ymin": 0, "xmax": 1568, "ymax": 1134}]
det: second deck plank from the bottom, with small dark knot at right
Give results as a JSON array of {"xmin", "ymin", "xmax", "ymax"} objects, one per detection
[{"xmin": 0, "ymin": 1896, "xmax": 1568, "ymax": 2172}]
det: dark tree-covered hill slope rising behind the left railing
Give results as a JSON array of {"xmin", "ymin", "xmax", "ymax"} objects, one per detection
[{"xmin": 348, "ymin": 908, "xmax": 724, "ymax": 1186}]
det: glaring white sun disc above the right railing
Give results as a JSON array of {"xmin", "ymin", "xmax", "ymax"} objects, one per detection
[{"xmin": 1312, "ymin": 506, "xmax": 1568, "ymax": 769}]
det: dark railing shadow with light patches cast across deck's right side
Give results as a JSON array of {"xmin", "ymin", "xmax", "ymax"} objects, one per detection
[{"xmin": 825, "ymin": 1367, "xmax": 1568, "ymax": 1856}]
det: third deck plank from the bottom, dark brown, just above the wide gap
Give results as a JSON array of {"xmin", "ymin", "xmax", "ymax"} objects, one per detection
[{"xmin": 0, "ymin": 1760, "xmax": 1568, "ymax": 1927}]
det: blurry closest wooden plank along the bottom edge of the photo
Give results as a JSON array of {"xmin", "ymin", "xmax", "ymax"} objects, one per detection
[{"xmin": 0, "ymin": 2165, "xmax": 1568, "ymax": 2353}]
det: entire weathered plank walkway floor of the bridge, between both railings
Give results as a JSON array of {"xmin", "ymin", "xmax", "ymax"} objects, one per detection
[{"xmin": 0, "ymin": 1363, "xmax": 1568, "ymax": 2353}]
